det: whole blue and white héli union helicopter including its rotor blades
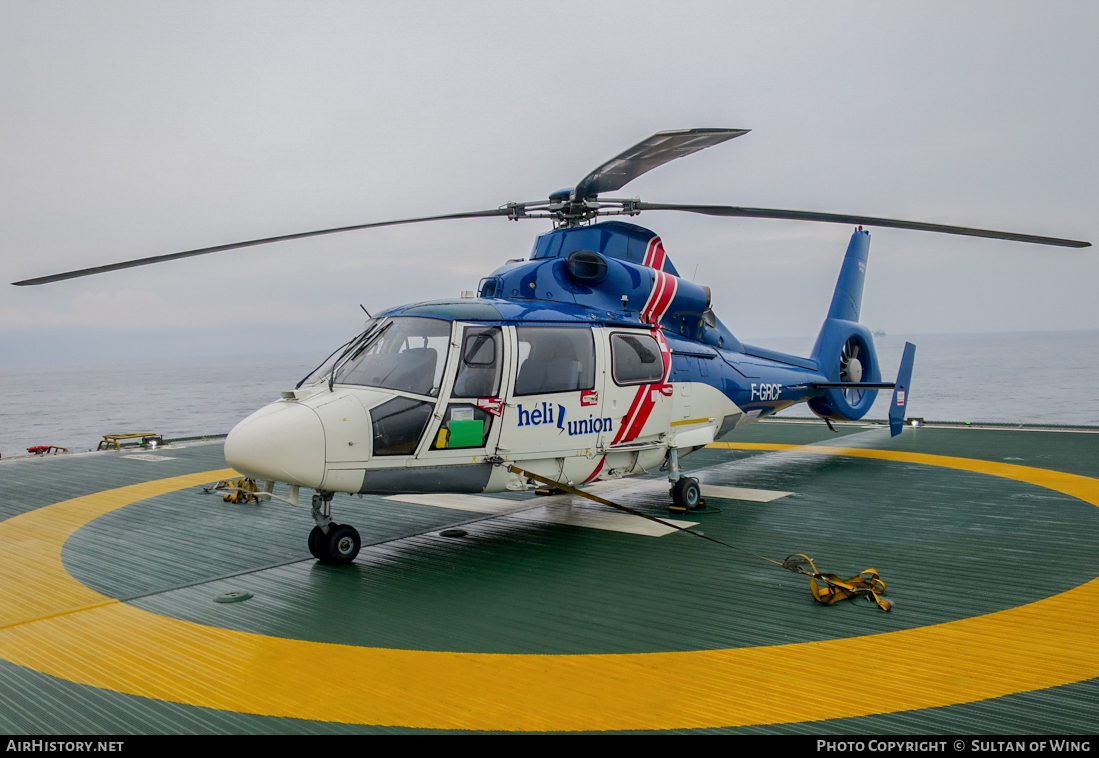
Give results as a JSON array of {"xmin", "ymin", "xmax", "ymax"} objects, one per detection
[{"xmin": 13, "ymin": 129, "xmax": 1090, "ymax": 565}]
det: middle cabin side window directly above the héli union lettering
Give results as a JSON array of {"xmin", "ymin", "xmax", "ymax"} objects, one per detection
[{"xmin": 515, "ymin": 326, "xmax": 596, "ymax": 394}]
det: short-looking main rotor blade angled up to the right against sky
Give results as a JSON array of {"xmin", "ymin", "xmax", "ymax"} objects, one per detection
[{"xmin": 576, "ymin": 129, "xmax": 750, "ymax": 200}]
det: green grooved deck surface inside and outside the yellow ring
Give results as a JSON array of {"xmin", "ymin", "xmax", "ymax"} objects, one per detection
[{"xmin": 0, "ymin": 422, "xmax": 1099, "ymax": 734}]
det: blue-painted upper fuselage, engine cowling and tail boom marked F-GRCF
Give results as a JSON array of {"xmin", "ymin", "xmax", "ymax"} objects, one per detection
[{"xmin": 379, "ymin": 222, "xmax": 878, "ymax": 417}]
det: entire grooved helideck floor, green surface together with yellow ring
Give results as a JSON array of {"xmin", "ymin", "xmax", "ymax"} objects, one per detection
[{"xmin": 0, "ymin": 422, "xmax": 1099, "ymax": 734}]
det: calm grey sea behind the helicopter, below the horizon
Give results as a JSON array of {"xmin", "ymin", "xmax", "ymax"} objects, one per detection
[{"xmin": 0, "ymin": 331, "xmax": 1099, "ymax": 458}]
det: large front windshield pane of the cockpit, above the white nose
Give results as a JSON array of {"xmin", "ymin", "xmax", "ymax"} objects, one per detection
[{"xmin": 333, "ymin": 316, "xmax": 451, "ymax": 397}]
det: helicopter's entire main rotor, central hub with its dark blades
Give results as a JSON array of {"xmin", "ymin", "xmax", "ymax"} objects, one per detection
[{"xmin": 12, "ymin": 129, "xmax": 1091, "ymax": 287}]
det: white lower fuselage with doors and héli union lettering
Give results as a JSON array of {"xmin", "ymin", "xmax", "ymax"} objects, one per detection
[{"xmin": 225, "ymin": 320, "xmax": 742, "ymax": 493}]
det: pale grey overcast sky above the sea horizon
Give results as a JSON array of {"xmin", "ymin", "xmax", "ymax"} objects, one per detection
[{"xmin": 0, "ymin": 0, "xmax": 1099, "ymax": 365}]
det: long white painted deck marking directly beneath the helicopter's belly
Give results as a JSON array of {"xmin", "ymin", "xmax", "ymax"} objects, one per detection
[{"xmin": 386, "ymin": 492, "xmax": 698, "ymax": 537}]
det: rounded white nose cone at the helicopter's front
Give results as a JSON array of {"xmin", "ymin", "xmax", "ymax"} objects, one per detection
[{"xmin": 225, "ymin": 402, "xmax": 324, "ymax": 489}]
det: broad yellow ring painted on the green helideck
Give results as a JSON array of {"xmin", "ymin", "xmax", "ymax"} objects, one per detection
[{"xmin": 0, "ymin": 443, "xmax": 1099, "ymax": 731}]
